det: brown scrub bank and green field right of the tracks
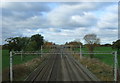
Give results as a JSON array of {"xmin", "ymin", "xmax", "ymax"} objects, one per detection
[{"xmin": 74, "ymin": 47, "xmax": 120, "ymax": 81}]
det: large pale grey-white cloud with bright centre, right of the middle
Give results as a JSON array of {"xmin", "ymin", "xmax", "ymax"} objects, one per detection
[{"xmin": 48, "ymin": 6, "xmax": 97, "ymax": 28}]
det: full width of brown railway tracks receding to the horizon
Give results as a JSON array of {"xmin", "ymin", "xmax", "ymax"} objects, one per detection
[{"xmin": 25, "ymin": 49, "xmax": 99, "ymax": 83}]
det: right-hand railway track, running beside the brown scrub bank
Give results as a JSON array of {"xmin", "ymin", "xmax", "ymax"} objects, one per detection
[{"xmin": 62, "ymin": 50, "xmax": 98, "ymax": 81}]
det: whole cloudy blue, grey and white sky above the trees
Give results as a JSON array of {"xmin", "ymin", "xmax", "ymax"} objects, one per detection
[{"xmin": 0, "ymin": 2, "xmax": 118, "ymax": 44}]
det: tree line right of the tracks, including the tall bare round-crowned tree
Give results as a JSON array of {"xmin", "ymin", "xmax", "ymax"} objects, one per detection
[{"xmin": 65, "ymin": 34, "xmax": 120, "ymax": 58}]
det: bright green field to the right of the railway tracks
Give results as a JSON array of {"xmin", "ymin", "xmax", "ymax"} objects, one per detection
[{"xmin": 75, "ymin": 47, "xmax": 120, "ymax": 66}]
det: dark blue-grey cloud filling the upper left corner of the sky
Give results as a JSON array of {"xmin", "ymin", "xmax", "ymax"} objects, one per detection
[{"xmin": 2, "ymin": 2, "xmax": 51, "ymax": 20}]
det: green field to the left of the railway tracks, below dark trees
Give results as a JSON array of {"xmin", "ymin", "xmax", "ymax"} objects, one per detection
[{"xmin": 2, "ymin": 49, "xmax": 48, "ymax": 69}]
